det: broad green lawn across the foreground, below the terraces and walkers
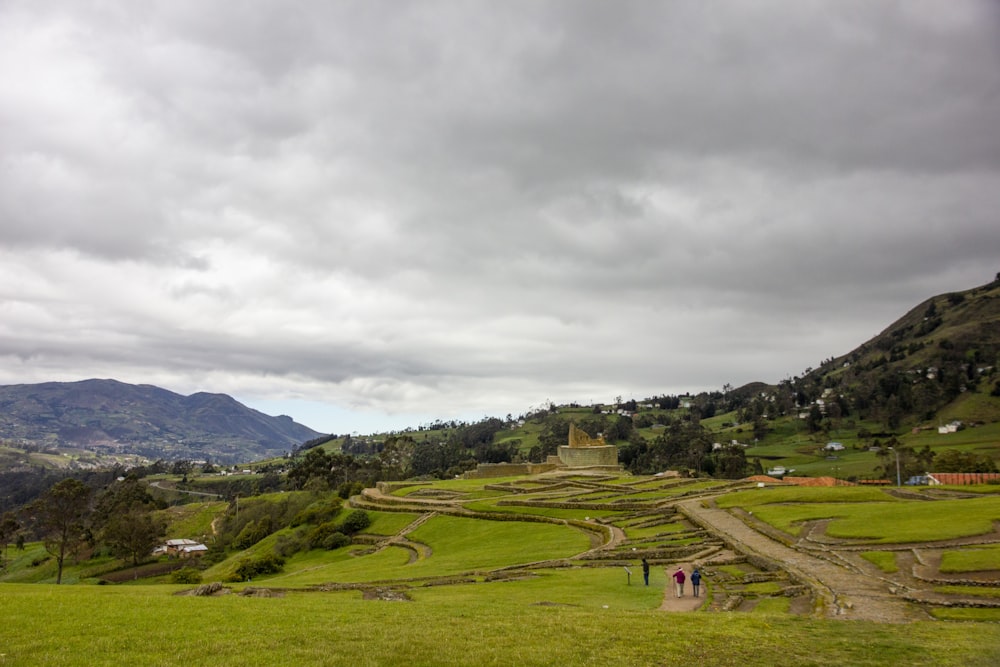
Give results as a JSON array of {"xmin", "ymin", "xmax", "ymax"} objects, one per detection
[{"xmin": 0, "ymin": 584, "xmax": 1000, "ymax": 667}]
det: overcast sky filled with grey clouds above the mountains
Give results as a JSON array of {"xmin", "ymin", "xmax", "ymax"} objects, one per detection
[{"xmin": 0, "ymin": 0, "xmax": 1000, "ymax": 433}]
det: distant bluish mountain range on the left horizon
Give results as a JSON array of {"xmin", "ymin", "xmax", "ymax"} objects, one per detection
[{"xmin": 0, "ymin": 380, "xmax": 320, "ymax": 463}]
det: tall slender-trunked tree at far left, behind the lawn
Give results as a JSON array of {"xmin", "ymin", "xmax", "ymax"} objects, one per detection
[{"xmin": 29, "ymin": 479, "xmax": 91, "ymax": 584}]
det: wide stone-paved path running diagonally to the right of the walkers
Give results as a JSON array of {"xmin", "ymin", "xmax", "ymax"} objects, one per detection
[{"xmin": 677, "ymin": 500, "xmax": 928, "ymax": 623}]
